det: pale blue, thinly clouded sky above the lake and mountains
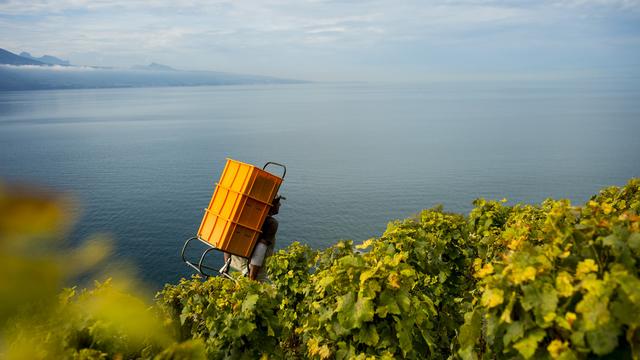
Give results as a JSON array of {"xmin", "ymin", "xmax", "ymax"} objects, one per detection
[{"xmin": 0, "ymin": 0, "xmax": 640, "ymax": 81}]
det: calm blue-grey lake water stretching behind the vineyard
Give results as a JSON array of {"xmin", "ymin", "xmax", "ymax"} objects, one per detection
[{"xmin": 0, "ymin": 83, "xmax": 640, "ymax": 286}]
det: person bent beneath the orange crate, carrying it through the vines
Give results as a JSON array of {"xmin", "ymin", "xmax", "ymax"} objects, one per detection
[{"xmin": 224, "ymin": 195, "xmax": 286, "ymax": 282}]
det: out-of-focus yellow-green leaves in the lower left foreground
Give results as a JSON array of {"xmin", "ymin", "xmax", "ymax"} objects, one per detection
[{"xmin": 0, "ymin": 183, "xmax": 204, "ymax": 359}]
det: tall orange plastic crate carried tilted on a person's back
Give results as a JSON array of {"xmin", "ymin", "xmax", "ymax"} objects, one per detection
[{"xmin": 198, "ymin": 159, "xmax": 282, "ymax": 257}]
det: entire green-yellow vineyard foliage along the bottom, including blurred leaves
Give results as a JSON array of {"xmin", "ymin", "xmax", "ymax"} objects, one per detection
[{"xmin": 0, "ymin": 179, "xmax": 640, "ymax": 359}]
